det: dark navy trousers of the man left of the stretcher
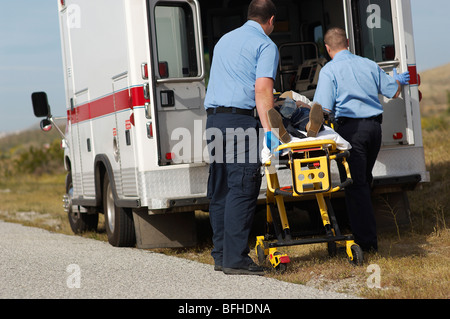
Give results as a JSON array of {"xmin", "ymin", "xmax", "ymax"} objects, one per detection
[{"xmin": 206, "ymin": 113, "xmax": 261, "ymax": 268}]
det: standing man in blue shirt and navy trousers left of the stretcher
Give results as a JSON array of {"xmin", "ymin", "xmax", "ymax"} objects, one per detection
[{"xmin": 205, "ymin": 0, "xmax": 278, "ymax": 275}]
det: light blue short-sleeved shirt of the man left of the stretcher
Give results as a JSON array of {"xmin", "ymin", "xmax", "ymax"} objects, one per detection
[{"xmin": 205, "ymin": 20, "xmax": 279, "ymax": 109}]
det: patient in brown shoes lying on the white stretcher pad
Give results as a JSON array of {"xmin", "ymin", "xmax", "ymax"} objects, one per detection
[{"xmin": 261, "ymin": 91, "xmax": 351, "ymax": 163}]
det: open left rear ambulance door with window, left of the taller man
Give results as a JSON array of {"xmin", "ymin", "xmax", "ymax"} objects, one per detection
[{"xmin": 148, "ymin": 0, "xmax": 206, "ymax": 165}]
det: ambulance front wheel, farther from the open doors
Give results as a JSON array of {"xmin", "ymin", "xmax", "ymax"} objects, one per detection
[{"xmin": 66, "ymin": 173, "xmax": 98, "ymax": 234}]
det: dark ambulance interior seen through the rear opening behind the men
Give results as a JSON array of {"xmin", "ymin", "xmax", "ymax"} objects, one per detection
[{"xmin": 200, "ymin": 0, "xmax": 345, "ymax": 100}]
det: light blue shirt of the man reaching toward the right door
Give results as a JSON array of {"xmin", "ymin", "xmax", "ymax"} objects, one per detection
[{"xmin": 314, "ymin": 50, "xmax": 398, "ymax": 118}]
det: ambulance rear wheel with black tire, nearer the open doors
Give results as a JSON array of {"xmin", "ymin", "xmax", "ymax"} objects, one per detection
[{"xmin": 103, "ymin": 174, "xmax": 136, "ymax": 247}]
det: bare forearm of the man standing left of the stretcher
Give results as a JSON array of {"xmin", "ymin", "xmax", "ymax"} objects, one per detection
[{"xmin": 255, "ymin": 78, "xmax": 274, "ymax": 132}]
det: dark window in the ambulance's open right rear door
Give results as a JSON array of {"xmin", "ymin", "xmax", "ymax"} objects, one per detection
[{"xmin": 352, "ymin": 0, "xmax": 395, "ymax": 62}]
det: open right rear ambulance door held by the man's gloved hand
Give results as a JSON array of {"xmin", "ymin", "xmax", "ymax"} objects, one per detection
[{"xmin": 346, "ymin": 0, "xmax": 417, "ymax": 147}]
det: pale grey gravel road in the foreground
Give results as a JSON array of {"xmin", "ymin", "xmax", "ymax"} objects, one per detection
[{"xmin": 0, "ymin": 221, "xmax": 354, "ymax": 299}]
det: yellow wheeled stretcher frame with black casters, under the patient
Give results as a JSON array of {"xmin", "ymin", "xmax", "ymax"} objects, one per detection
[{"xmin": 255, "ymin": 140, "xmax": 363, "ymax": 271}]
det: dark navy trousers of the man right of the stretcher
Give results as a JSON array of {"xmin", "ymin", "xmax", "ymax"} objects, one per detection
[{"xmin": 336, "ymin": 118, "xmax": 382, "ymax": 250}]
